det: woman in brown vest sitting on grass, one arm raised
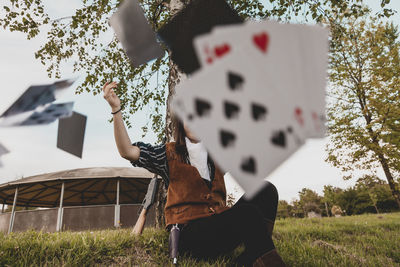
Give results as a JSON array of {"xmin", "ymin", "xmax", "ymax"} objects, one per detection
[{"xmin": 103, "ymin": 82, "xmax": 285, "ymax": 266}]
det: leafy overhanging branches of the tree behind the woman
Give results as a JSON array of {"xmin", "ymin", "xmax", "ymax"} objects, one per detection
[{"xmin": 0, "ymin": 0, "xmax": 397, "ymax": 140}]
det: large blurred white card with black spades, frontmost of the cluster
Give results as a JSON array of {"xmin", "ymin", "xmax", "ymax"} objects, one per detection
[{"xmin": 172, "ymin": 50, "xmax": 304, "ymax": 197}]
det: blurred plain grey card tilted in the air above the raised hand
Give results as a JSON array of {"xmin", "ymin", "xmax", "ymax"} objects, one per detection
[{"xmin": 110, "ymin": 0, "xmax": 165, "ymax": 68}]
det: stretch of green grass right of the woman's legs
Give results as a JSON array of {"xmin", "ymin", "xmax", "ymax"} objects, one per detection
[{"xmin": 274, "ymin": 213, "xmax": 400, "ymax": 266}]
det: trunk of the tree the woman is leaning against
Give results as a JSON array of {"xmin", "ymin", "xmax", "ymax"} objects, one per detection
[{"xmin": 155, "ymin": 0, "xmax": 184, "ymax": 228}]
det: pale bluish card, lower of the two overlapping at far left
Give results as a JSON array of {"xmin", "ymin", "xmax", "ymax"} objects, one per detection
[{"xmin": 19, "ymin": 102, "xmax": 74, "ymax": 126}]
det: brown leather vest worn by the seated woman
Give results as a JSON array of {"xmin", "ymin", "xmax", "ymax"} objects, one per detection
[{"xmin": 165, "ymin": 142, "xmax": 228, "ymax": 226}]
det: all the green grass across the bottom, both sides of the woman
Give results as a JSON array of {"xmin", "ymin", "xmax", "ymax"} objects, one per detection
[{"xmin": 0, "ymin": 213, "xmax": 400, "ymax": 266}]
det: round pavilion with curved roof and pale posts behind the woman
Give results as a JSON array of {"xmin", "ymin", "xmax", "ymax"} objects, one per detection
[{"xmin": 0, "ymin": 167, "xmax": 157, "ymax": 233}]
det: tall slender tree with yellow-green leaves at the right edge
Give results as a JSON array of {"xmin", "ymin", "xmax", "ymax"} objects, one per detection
[{"xmin": 327, "ymin": 16, "xmax": 400, "ymax": 207}]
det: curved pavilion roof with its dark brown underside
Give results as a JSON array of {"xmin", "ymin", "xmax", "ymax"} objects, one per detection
[{"xmin": 0, "ymin": 167, "xmax": 154, "ymax": 207}]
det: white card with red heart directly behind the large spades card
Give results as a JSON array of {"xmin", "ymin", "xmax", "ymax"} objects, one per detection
[{"xmin": 194, "ymin": 21, "xmax": 310, "ymax": 138}]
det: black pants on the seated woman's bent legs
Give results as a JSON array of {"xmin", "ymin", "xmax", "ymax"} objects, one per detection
[{"xmin": 179, "ymin": 183, "xmax": 278, "ymax": 265}]
